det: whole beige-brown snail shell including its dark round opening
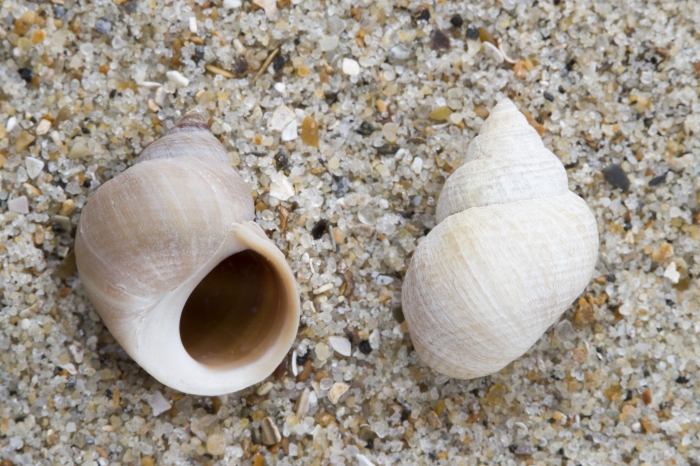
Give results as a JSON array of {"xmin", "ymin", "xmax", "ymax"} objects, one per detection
[{"xmin": 75, "ymin": 115, "xmax": 299, "ymax": 396}]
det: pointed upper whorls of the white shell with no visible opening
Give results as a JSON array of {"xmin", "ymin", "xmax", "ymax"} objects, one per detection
[{"xmin": 436, "ymin": 99, "xmax": 569, "ymax": 223}]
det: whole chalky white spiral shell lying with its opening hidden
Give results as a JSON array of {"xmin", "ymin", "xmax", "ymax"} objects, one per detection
[{"xmin": 402, "ymin": 99, "xmax": 598, "ymax": 379}]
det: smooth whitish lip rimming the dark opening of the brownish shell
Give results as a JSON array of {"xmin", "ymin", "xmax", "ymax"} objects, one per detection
[{"xmin": 132, "ymin": 222, "xmax": 301, "ymax": 396}]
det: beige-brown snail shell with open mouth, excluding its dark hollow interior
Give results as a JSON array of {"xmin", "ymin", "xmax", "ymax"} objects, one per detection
[{"xmin": 75, "ymin": 115, "xmax": 299, "ymax": 395}]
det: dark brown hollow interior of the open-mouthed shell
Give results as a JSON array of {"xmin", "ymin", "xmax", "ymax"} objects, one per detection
[{"xmin": 180, "ymin": 250, "xmax": 288, "ymax": 369}]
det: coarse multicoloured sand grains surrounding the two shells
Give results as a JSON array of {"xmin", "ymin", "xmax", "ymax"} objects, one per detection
[{"xmin": 0, "ymin": 0, "xmax": 700, "ymax": 466}]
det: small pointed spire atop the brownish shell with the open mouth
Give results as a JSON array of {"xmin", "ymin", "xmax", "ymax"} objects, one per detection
[{"xmin": 134, "ymin": 112, "xmax": 229, "ymax": 164}]
